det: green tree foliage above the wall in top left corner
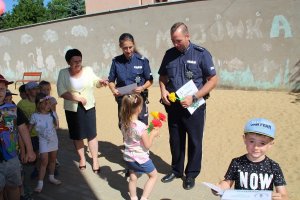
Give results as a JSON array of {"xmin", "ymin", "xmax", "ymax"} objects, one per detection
[{"xmin": 0, "ymin": 0, "xmax": 85, "ymax": 29}]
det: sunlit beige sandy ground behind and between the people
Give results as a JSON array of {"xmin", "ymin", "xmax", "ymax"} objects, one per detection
[{"xmin": 9, "ymin": 85, "xmax": 300, "ymax": 200}]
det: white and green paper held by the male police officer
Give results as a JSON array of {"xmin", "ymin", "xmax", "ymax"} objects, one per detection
[{"xmin": 176, "ymin": 80, "xmax": 205, "ymax": 115}]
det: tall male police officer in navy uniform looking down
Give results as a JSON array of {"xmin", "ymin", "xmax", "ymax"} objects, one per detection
[{"xmin": 158, "ymin": 22, "xmax": 217, "ymax": 190}]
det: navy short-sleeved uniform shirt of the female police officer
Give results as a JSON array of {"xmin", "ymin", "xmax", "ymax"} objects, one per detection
[{"xmin": 108, "ymin": 53, "xmax": 153, "ymax": 87}]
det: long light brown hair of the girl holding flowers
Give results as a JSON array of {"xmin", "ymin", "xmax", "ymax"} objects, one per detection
[{"xmin": 120, "ymin": 94, "xmax": 143, "ymax": 130}]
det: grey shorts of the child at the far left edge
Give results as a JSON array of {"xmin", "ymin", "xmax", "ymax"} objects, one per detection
[{"xmin": 0, "ymin": 156, "xmax": 22, "ymax": 191}]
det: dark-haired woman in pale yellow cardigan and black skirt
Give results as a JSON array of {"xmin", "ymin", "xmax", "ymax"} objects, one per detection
[{"xmin": 57, "ymin": 49, "xmax": 106, "ymax": 173}]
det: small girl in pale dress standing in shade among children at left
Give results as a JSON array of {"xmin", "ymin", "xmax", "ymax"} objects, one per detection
[{"xmin": 29, "ymin": 93, "xmax": 61, "ymax": 192}]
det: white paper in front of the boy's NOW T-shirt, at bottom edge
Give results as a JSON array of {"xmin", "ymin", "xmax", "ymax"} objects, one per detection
[{"xmin": 221, "ymin": 190, "xmax": 272, "ymax": 200}]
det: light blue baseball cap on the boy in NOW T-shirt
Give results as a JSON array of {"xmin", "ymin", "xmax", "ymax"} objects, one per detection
[{"xmin": 244, "ymin": 118, "xmax": 275, "ymax": 139}]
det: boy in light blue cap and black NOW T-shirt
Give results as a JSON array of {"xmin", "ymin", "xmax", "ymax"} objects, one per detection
[{"xmin": 213, "ymin": 118, "xmax": 288, "ymax": 200}]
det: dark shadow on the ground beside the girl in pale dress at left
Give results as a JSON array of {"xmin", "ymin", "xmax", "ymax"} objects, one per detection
[{"xmin": 24, "ymin": 129, "xmax": 97, "ymax": 200}]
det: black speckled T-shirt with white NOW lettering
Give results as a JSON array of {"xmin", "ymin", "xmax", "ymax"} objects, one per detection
[{"xmin": 225, "ymin": 155, "xmax": 286, "ymax": 190}]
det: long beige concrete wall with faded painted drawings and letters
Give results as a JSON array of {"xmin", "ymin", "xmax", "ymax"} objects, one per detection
[{"xmin": 0, "ymin": 0, "xmax": 300, "ymax": 90}]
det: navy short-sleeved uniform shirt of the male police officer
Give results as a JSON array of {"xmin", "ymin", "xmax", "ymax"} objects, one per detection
[{"xmin": 158, "ymin": 43, "xmax": 216, "ymax": 92}]
